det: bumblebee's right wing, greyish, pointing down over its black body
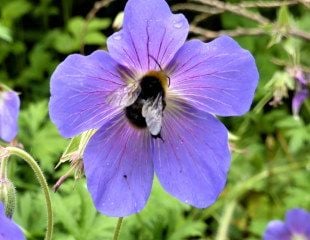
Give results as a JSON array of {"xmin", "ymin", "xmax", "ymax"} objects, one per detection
[{"xmin": 142, "ymin": 94, "xmax": 163, "ymax": 136}]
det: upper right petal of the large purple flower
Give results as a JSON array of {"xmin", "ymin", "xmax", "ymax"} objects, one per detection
[{"xmin": 167, "ymin": 36, "xmax": 258, "ymax": 116}]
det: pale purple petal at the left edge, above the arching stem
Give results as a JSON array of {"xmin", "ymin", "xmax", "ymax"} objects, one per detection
[{"xmin": 0, "ymin": 91, "xmax": 20, "ymax": 142}]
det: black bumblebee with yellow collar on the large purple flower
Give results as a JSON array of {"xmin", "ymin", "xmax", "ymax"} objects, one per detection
[{"xmin": 108, "ymin": 68, "xmax": 169, "ymax": 139}]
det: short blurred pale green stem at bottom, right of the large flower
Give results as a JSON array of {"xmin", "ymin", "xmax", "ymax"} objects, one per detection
[{"xmin": 215, "ymin": 200, "xmax": 237, "ymax": 240}]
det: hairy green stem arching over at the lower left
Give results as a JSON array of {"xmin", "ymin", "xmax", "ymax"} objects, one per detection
[{"xmin": 6, "ymin": 147, "xmax": 53, "ymax": 240}]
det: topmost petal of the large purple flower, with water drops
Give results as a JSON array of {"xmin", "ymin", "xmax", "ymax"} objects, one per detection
[{"xmin": 107, "ymin": 0, "xmax": 189, "ymax": 73}]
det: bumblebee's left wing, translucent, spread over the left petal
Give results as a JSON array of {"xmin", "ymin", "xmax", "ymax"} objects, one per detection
[{"xmin": 107, "ymin": 83, "xmax": 141, "ymax": 107}]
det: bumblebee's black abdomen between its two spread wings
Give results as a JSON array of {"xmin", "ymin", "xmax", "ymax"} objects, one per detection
[{"xmin": 125, "ymin": 99, "xmax": 146, "ymax": 128}]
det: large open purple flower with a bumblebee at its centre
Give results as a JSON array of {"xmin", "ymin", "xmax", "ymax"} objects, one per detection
[{"xmin": 50, "ymin": 0, "xmax": 258, "ymax": 216}]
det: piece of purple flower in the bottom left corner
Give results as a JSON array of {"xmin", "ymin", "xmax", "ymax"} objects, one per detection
[{"xmin": 0, "ymin": 202, "xmax": 25, "ymax": 240}]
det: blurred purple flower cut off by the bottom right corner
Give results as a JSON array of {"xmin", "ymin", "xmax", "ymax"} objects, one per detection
[{"xmin": 264, "ymin": 208, "xmax": 310, "ymax": 240}]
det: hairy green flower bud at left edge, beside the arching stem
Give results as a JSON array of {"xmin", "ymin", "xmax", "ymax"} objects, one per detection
[{"xmin": 0, "ymin": 179, "xmax": 16, "ymax": 218}]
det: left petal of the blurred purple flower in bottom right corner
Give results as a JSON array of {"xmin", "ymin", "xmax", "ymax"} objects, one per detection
[{"xmin": 264, "ymin": 220, "xmax": 291, "ymax": 240}]
